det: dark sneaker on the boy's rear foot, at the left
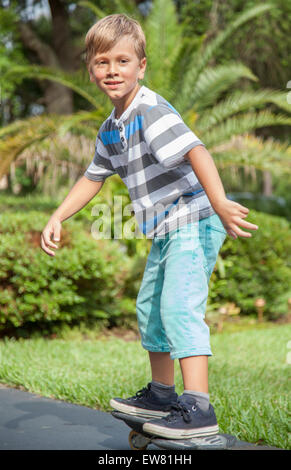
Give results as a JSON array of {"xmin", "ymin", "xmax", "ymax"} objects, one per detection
[{"xmin": 110, "ymin": 383, "xmax": 178, "ymax": 418}]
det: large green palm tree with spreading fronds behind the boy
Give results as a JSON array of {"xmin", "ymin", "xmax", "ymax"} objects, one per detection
[{"xmin": 0, "ymin": 0, "xmax": 291, "ymax": 193}]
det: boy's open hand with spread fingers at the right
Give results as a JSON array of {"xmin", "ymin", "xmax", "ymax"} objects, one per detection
[{"xmin": 214, "ymin": 198, "xmax": 259, "ymax": 240}]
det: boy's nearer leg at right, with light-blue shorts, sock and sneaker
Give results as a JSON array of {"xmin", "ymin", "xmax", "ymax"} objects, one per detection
[{"xmin": 144, "ymin": 217, "xmax": 225, "ymax": 439}]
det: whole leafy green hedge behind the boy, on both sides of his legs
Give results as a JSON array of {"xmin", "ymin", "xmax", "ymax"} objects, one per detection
[{"xmin": 0, "ymin": 199, "xmax": 291, "ymax": 335}]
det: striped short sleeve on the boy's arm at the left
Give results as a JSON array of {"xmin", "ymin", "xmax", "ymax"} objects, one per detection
[{"xmin": 84, "ymin": 134, "xmax": 115, "ymax": 181}]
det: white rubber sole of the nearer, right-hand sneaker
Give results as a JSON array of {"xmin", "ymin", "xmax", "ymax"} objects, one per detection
[{"xmin": 143, "ymin": 423, "xmax": 219, "ymax": 439}]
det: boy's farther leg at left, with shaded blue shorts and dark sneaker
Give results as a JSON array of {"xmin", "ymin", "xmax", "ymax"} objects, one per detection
[{"xmin": 110, "ymin": 240, "xmax": 178, "ymax": 418}]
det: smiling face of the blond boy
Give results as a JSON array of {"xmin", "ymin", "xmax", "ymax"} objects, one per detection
[{"xmin": 88, "ymin": 36, "xmax": 146, "ymax": 109}]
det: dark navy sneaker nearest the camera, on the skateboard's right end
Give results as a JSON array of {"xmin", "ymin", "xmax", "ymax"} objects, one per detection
[{"xmin": 143, "ymin": 396, "xmax": 218, "ymax": 439}]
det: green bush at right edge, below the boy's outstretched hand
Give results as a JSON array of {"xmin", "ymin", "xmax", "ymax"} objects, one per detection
[{"xmin": 214, "ymin": 210, "xmax": 291, "ymax": 319}]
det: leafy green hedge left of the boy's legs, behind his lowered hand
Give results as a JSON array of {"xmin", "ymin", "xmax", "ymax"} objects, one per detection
[{"xmin": 0, "ymin": 211, "xmax": 141, "ymax": 331}]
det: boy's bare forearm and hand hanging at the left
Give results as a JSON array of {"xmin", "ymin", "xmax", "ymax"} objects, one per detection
[{"xmin": 40, "ymin": 176, "xmax": 104, "ymax": 256}]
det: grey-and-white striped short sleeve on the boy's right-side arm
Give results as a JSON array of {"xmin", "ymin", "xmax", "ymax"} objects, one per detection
[{"xmin": 143, "ymin": 103, "xmax": 205, "ymax": 168}]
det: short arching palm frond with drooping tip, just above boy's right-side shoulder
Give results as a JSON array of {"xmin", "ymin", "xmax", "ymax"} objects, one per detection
[{"xmin": 175, "ymin": 62, "xmax": 258, "ymax": 113}]
